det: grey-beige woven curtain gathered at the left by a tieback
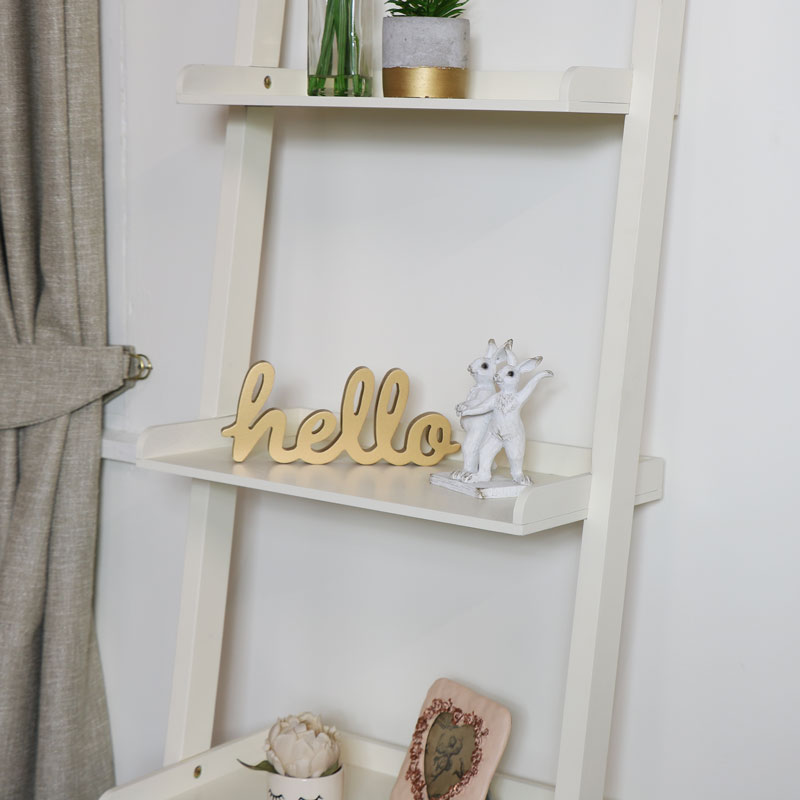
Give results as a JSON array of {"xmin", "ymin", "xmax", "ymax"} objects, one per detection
[{"xmin": 0, "ymin": 0, "xmax": 134, "ymax": 800}]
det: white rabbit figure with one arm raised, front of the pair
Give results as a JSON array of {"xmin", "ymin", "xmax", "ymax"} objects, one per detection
[{"xmin": 463, "ymin": 349, "xmax": 553, "ymax": 486}]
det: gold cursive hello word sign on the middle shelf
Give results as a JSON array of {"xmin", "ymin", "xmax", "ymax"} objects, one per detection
[{"xmin": 222, "ymin": 361, "xmax": 461, "ymax": 466}]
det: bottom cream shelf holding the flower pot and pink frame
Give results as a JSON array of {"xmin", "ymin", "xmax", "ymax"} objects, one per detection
[{"xmin": 101, "ymin": 728, "xmax": 554, "ymax": 800}]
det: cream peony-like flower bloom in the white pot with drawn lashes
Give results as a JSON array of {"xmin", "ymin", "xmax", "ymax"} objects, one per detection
[{"xmin": 265, "ymin": 712, "xmax": 339, "ymax": 778}]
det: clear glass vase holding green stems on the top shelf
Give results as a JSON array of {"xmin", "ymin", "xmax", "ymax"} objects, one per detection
[{"xmin": 308, "ymin": 0, "xmax": 372, "ymax": 97}]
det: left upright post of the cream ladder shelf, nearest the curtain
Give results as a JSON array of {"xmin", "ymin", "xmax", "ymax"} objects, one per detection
[{"xmin": 164, "ymin": 0, "xmax": 285, "ymax": 764}]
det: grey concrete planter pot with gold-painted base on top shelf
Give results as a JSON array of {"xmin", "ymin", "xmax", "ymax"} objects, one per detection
[{"xmin": 383, "ymin": 17, "xmax": 469, "ymax": 97}]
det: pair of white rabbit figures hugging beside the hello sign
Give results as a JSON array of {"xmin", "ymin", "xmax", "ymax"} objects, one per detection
[{"xmin": 450, "ymin": 339, "xmax": 553, "ymax": 486}]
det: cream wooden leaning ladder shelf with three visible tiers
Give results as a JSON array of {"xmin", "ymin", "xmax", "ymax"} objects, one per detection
[{"xmin": 107, "ymin": 0, "xmax": 685, "ymax": 800}]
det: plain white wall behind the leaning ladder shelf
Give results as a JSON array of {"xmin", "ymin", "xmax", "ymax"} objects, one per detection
[{"xmin": 97, "ymin": 0, "xmax": 800, "ymax": 800}]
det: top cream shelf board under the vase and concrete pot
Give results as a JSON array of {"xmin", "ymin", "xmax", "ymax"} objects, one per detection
[{"xmin": 178, "ymin": 64, "xmax": 632, "ymax": 114}]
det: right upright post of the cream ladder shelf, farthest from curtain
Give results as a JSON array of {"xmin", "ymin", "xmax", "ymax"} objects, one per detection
[{"xmin": 555, "ymin": 0, "xmax": 685, "ymax": 800}]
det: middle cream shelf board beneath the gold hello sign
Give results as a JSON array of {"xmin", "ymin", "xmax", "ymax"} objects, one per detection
[{"xmin": 136, "ymin": 410, "xmax": 664, "ymax": 536}]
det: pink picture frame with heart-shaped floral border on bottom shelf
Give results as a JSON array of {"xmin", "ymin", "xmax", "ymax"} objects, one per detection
[{"xmin": 390, "ymin": 678, "xmax": 511, "ymax": 800}]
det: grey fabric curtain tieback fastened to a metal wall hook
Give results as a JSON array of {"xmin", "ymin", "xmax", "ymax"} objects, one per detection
[{"xmin": 0, "ymin": 345, "xmax": 153, "ymax": 429}]
